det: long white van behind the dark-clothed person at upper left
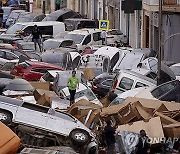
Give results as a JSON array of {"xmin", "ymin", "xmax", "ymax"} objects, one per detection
[{"xmin": 4, "ymin": 21, "xmax": 65, "ymax": 36}]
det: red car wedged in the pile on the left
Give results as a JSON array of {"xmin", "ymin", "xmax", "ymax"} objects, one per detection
[{"xmin": 11, "ymin": 61, "xmax": 63, "ymax": 81}]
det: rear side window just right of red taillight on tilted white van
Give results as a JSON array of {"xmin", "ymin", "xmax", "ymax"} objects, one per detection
[{"xmin": 119, "ymin": 77, "xmax": 134, "ymax": 90}]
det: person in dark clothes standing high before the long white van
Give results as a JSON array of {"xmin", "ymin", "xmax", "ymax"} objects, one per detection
[{"xmin": 32, "ymin": 25, "xmax": 42, "ymax": 52}]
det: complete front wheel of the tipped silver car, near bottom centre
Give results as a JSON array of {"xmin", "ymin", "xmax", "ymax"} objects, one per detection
[{"xmin": 70, "ymin": 129, "xmax": 90, "ymax": 147}]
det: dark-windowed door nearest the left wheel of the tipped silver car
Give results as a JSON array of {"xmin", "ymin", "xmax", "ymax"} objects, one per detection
[{"xmin": 15, "ymin": 103, "xmax": 49, "ymax": 128}]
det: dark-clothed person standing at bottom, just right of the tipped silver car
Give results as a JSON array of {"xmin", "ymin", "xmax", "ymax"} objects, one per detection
[{"xmin": 104, "ymin": 120, "xmax": 116, "ymax": 154}]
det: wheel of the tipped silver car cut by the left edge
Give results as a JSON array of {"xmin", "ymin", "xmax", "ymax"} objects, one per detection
[{"xmin": 0, "ymin": 110, "xmax": 12, "ymax": 125}]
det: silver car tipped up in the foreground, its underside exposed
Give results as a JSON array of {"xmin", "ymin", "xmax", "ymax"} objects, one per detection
[{"xmin": 0, "ymin": 96, "xmax": 97, "ymax": 153}]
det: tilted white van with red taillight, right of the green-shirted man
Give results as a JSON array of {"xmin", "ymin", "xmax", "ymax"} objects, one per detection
[{"xmin": 112, "ymin": 70, "xmax": 156, "ymax": 93}]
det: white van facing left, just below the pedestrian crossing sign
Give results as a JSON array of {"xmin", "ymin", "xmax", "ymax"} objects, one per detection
[{"xmin": 64, "ymin": 29, "xmax": 102, "ymax": 53}]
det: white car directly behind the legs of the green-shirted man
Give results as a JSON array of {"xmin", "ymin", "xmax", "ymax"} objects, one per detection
[{"xmin": 60, "ymin": 83, "xmax": 103, "ymax": 106}]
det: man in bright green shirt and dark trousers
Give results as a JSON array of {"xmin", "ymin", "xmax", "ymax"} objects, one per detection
[{"xmin": 68, "ymin": 71, "xmax": 79, "ymax": 105}]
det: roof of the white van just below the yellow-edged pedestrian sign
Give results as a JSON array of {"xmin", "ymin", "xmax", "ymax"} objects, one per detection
[{"xmin": 68, "ymin": 28, "xmax": 101, "ymax": 35}]
